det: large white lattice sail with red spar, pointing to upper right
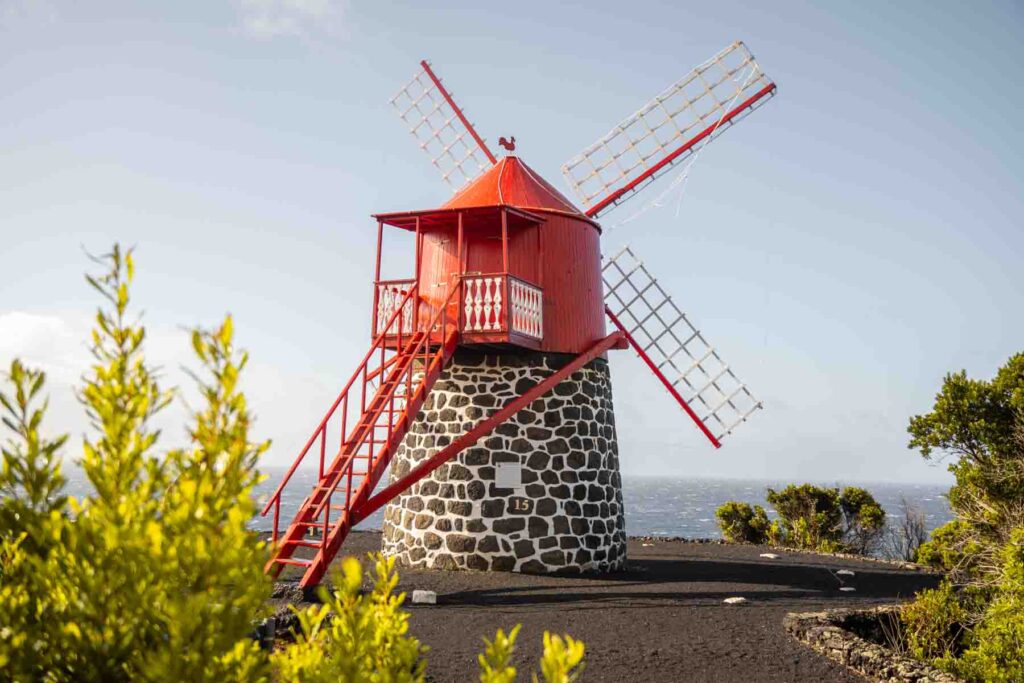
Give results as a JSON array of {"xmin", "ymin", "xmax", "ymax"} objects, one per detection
[{"xmin": 562, "ymin": 41, "xmax": 775, "ymax": 216}]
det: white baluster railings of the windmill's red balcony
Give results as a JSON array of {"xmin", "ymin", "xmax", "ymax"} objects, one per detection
[{"xmin": 372, "ymin": 272, "xmax": 544, "ymax": 349}]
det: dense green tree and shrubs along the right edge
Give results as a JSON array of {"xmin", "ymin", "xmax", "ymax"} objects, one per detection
[{"xmin": 903, "ymin": 353, "xmax": 1024, "ymax": 681}]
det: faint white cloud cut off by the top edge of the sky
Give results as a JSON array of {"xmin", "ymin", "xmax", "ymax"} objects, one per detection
[{"xmin": 232, "ymin": 0, "xmax": 347, "ymax": 40}]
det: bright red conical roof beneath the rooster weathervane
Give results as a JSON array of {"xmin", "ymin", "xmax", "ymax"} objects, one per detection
[{"xmin": 441, "ymin": 157, "xmax": 589, "ymax": 220}]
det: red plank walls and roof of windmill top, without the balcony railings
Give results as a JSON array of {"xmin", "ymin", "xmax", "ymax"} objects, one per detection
[{"xmin": 378, "ymin": 157, "xmax": 605, "ymax": 353}]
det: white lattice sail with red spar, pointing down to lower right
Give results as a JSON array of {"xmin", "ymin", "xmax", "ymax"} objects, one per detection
[{"xmin": 601, "ymin": 247, "xmax": 762, "ymax": 445}]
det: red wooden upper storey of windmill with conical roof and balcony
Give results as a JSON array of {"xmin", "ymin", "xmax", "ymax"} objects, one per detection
[{"xmin": 372, "ymin": 157, "xmax": 605, "ymax": 353}]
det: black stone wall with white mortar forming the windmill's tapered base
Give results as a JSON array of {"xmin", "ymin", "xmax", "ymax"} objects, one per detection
[{"xmin": 383, "ymin": 349, "xmax": 626, "ymax": 573}]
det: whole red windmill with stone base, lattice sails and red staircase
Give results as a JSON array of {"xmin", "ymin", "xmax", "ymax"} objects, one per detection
[{"xmin": 262, "ymin": 42, "xmax": 775, "ymax": 586}]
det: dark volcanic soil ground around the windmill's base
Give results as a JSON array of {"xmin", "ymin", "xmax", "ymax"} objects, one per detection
[{"xmin": 270, "ymin": 531, "xmax": 938, "ymax": 683}]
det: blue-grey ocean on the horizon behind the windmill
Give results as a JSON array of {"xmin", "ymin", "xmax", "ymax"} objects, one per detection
[{"xmin": 59, "ymin": 468, "xmax": 952, "ymax": 539}]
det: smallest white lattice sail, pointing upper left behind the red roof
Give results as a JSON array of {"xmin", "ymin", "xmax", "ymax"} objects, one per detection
[{"xmin": 390, "ymin": 60, "xmax": 495, "ymax": 191}]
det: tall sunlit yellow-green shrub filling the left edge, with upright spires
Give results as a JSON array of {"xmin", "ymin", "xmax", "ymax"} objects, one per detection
[{"xmin": 0, "ymin": 248, "xmax": 269, "ymax": 681}]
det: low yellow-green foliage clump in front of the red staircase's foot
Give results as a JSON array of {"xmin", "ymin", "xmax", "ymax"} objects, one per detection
[{"xmin": 271, "ymin": 557, "xmax": 426, "ymax": 683}]
